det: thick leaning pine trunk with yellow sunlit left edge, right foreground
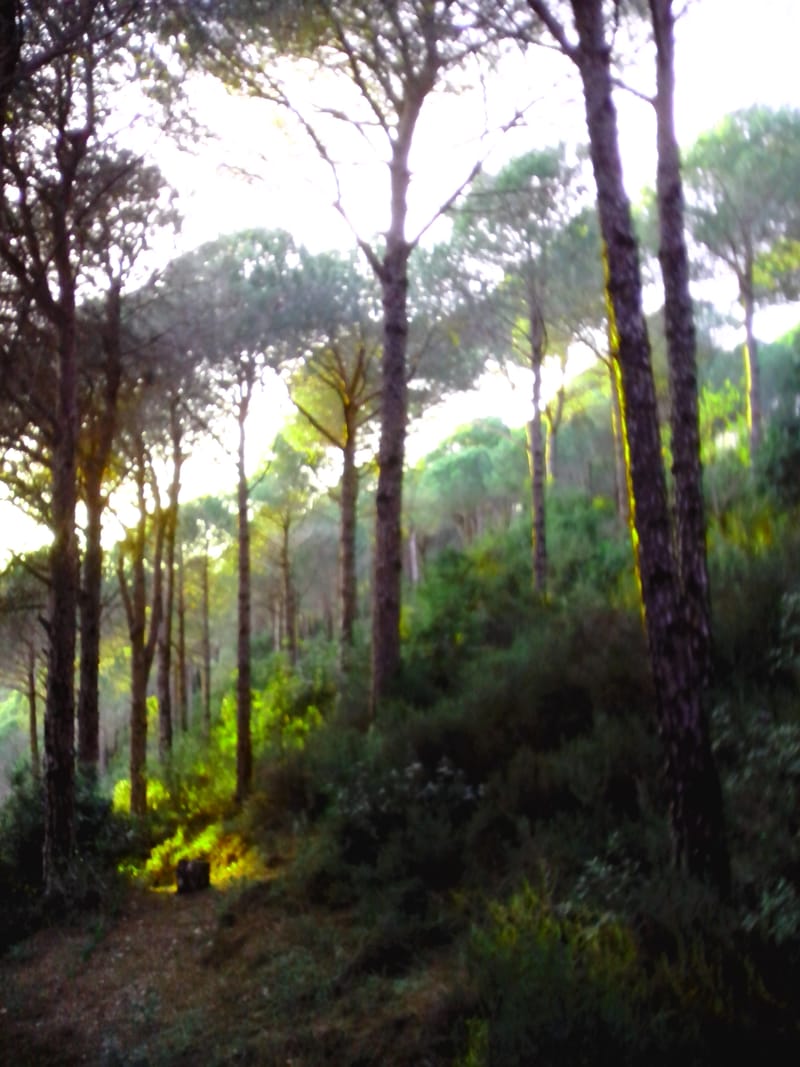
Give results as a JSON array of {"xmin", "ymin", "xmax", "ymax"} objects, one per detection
[{"xmin": 572, "ymin": 0, "xmax": 730, "ymax": 892}]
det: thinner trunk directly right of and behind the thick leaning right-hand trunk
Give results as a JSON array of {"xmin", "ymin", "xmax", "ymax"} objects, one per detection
[{"xmin": 650, "ymin": 0, "xmax": 711, "ymax": 687}]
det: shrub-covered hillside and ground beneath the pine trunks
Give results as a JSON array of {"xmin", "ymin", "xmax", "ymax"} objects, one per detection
[{"xmin": 0, "ymin": 503, "xmax": 800, "ymax": 1067}]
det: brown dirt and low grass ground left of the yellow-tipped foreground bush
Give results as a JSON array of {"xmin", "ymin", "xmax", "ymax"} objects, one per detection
[{"xmin": 0, "ymin": 857, "xmax": 463, "ymax": 1067}]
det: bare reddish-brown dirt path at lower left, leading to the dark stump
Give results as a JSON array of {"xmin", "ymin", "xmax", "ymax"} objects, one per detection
[{"xmin": 0, "ymin": 890, "xmax": 222, "ymax": 1067}]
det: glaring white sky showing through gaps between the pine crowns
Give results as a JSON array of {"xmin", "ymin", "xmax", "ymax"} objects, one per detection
[{"xmin": 0, "ymin": 0, "xmax": 800, "ymax": 563}]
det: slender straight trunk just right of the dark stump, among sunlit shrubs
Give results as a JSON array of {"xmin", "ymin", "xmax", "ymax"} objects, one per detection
[{"xmin": 236, "ymin": 385, "xmax": 253, "ymax": 803}]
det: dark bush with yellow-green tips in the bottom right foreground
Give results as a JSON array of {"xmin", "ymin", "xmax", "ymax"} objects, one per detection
[{"xmin": 460, "ymin": 879, "xmax": 800, "ymax": 1067}]
